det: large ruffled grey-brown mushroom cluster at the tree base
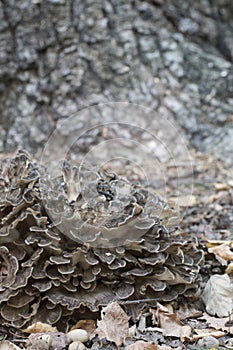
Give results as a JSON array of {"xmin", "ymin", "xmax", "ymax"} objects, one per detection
[{"xmin": 0, "ymin": 152, "xmax": 203, "ymax": 329}]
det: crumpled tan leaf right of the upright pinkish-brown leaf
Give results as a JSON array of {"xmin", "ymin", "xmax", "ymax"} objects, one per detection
[{"xmin": 151, "ymin": 303, "xmax": 191, "ymax": 341}]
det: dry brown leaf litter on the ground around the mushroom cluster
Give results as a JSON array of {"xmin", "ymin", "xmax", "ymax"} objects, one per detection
[{"xmin": 0, "ymin": 150, "xmax": 233, "ymax": 350}]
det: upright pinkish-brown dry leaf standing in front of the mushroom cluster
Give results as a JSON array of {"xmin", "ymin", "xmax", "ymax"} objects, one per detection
[{"xmin": 96, "ymin": 301, "xmax": 129, "ymax": 346}]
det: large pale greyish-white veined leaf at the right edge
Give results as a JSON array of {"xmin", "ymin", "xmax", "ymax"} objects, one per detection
[{"xmin": 202, "ymin": 274, "xmax": 233, "ymax": 317}]
